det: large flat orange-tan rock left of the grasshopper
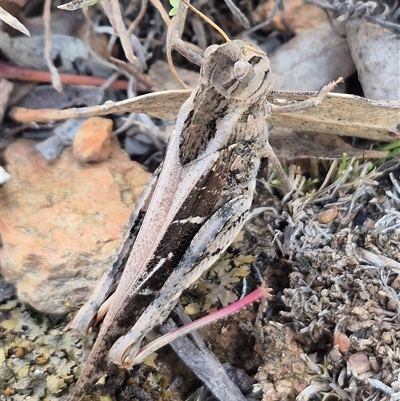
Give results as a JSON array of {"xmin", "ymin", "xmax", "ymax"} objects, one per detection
[{"xmin": 0, "ymin": 139, "xmax": 150, "ymax": 314}]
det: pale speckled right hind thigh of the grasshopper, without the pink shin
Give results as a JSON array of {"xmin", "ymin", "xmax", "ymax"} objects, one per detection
[{"xmin": 110, "ymin": 195, "xmax": 252, "ymax": 368}]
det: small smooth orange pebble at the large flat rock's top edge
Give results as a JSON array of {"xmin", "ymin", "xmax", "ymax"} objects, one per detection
[{"xmin": 72, "ymin": 117, "xmax": 112, "ymax": 162}]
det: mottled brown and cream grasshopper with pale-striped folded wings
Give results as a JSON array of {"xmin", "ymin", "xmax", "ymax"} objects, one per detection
[{"xmin": 68, "ymin": 5, "xmax": 334, "ymax": 401}]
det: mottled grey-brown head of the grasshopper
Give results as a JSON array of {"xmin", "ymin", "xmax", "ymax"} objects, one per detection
[{"xmin": 202, "ymin": 40, "xmax": 270, "ymax": 102}]
